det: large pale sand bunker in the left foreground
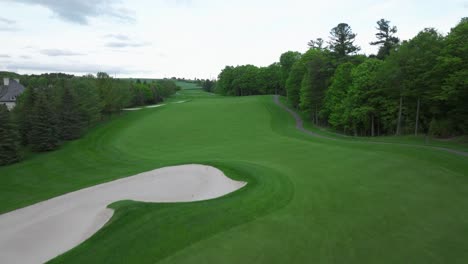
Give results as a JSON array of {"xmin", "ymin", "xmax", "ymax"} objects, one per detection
[{"xmin": 0, "ymin": 165, "xmax": 246, "ymax": 264}]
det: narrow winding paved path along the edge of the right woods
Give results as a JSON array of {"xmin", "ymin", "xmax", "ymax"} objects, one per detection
[{"xmin": 273, "ymin": 95, "xmax": 468, "ymax": 157}]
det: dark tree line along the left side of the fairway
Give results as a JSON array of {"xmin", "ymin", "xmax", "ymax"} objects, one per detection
[{"xmin": 0, "ymin": 72, "xmax": 180, "ymax": 165}]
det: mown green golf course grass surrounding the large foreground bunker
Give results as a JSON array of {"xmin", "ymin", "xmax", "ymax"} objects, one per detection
[{"xmin": 0, "ymin": 90, "xmax": 468, "ymax": 263}]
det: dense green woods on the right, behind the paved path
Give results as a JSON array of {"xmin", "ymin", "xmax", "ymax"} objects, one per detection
[{"xmin": 213, "ymin": 18, "xmax": 468, "ymax": 137}]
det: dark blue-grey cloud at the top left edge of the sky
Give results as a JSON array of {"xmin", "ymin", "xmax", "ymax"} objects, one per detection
[{"xmin": 10, "ymin": 0, "xmax": 135, "ymax": 25}]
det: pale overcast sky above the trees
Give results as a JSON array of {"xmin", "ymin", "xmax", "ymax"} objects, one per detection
[{"xmin": 0, "ymin": 0, "xmax": 468, "ymax": 79}]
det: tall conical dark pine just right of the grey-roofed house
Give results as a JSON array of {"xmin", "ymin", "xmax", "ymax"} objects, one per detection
[{"xmin": 29, "ymin": 89, "xmax": 59, "ymax": 152}]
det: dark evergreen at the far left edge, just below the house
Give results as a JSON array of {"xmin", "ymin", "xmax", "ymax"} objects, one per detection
[{"xmin": 0, "ymin": 104, "xmax": 21, "ymax": 166}]
